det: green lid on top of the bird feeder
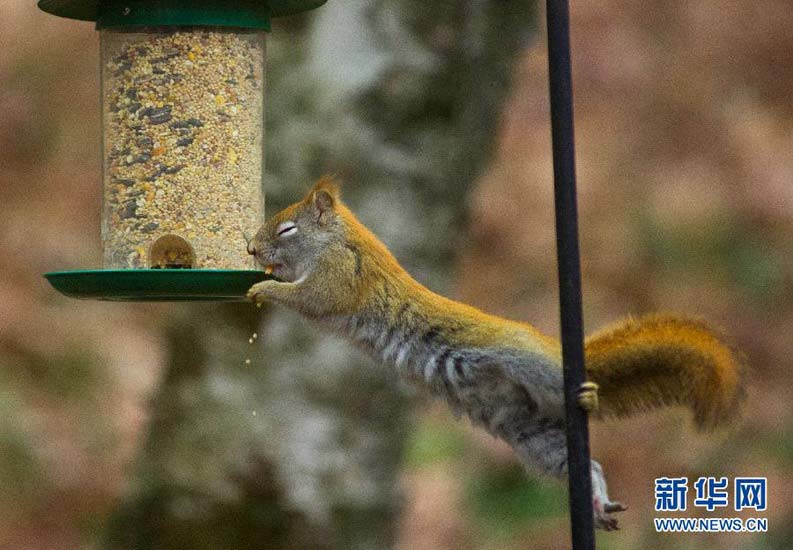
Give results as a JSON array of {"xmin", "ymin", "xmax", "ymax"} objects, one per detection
[{"xmin": 38, "ymin": 0, "xmax": 326, "ymax": 30}]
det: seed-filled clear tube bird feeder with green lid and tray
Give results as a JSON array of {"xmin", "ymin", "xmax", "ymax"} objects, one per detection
[{"xmin": 38, "ymin": 0, "xmax": 325, "ymax": 301}]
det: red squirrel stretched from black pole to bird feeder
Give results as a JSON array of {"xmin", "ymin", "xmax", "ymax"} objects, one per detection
[{"xmin": 248, "ymin": 177, "xmax": 744, "ymax": 530}]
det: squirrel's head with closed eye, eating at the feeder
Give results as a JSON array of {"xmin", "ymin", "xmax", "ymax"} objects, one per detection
[{"xmin": 248, "ymin": 176, "xmax": 344, "ymax": 282}]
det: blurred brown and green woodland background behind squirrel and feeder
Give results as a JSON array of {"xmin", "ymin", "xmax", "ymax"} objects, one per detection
[{"xmin": 0, "ymin": 0, "xmax": 793, "ymax": 550}]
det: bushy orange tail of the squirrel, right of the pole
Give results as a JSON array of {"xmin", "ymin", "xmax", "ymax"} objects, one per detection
[{"xmin": 585, "ymin": 315, "xmax": 744, "ymax": 430}]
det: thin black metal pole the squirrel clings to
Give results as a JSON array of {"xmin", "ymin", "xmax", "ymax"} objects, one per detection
[{"xmin": 546, "ymin": 0, "xmax": 595, "ymax": 550}]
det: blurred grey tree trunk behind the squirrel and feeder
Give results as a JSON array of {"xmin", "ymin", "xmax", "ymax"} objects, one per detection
[{"xmin": 107, "ymin": 0, "xmax": 534, "ymax": 549}]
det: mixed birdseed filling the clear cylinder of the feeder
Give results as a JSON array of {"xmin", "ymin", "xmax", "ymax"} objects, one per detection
[{"xmin": 102, "ymin": 28, "xmax": 264, "ymax": 269}]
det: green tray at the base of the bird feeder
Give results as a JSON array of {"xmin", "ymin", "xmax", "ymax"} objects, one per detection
[{"xmin": 44, "ymin": 269, "xmax": 268, "ymax": 302}]
